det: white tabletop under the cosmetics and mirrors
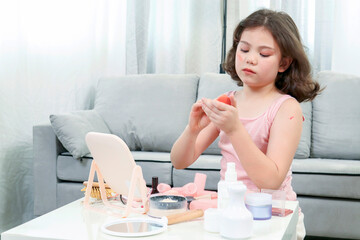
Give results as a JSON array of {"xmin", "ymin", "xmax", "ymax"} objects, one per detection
[{"xmin": 1, "ymin": 199, "xmax": 298, "ymax": 240}]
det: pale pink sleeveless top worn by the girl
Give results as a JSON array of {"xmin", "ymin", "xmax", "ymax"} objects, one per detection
[{"xmin": 219, "ymin": 95, "xmax": 296, "ymax": 200}]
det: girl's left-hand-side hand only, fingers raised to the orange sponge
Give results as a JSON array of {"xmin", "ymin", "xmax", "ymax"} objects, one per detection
[{"xmin": 189, "ymin": 100, "xmax": 210, "ymax": 133}]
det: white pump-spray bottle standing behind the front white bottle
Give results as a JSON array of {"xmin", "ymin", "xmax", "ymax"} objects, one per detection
[{"xmin": 218, "ymin": 162, "xmax": 243, "ymax": 210}]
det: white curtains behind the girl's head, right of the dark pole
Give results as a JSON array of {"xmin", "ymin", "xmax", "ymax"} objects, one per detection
[{"xmin": 227, "ymin": 0, "xmax": 360, "ymax": 75}]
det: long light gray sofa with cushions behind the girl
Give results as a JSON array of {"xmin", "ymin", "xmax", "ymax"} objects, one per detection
[{"xmin": 33, "ymin": 72, "xmax": 360, "ymax": 239}]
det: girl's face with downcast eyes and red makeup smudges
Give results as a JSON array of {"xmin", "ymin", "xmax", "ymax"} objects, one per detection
[{"xmin": 235, "ymin": 27, "xmax": 287, "ymax": 88}]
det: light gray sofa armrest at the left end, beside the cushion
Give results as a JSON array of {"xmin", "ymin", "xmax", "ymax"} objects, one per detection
[{"xmin": 33, "ymin": 124, "xmax": 66, "ymax": 216}]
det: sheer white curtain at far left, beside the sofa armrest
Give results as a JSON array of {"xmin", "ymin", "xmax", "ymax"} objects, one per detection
[{"xmin": 0, "ymin": 0, "xmax": 126, "ymax": 232}]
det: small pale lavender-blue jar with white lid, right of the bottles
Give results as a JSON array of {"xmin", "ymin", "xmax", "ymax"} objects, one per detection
[{"xmin": 245, "ymin": 193, "xmax": 272, "ymax": 220}]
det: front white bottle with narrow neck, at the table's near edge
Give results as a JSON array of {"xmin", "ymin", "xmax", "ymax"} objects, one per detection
[{"xmin": 220, "ymin": 184, "xmax": 254, "ymax": 238}]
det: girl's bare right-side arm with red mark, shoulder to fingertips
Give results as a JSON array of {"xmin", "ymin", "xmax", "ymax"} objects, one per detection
[{"xmin": 201, "ymin": 96, "xmax": 302, "ymax": 189}]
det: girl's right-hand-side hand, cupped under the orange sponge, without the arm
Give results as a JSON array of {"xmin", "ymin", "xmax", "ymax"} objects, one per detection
[{"xmin": 201, "ymin": 94, "xmax": 240, "ymax": 135}]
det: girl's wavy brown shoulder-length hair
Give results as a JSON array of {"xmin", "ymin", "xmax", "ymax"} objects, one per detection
[{"xmin": 223, "ymin": 9, "xmax": 320, "ymax": 102}]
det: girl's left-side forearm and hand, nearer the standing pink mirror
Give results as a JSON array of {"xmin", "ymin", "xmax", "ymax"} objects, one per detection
[{"xmin": 170, "ymin": 102, "xmax": 219, "ymax": 169}]
